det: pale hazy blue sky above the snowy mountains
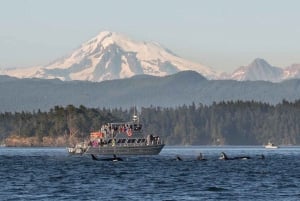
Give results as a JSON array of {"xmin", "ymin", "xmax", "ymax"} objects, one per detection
[{"xmin": 0, "ymin": 0, "xmax": 300, "ymax": 72}]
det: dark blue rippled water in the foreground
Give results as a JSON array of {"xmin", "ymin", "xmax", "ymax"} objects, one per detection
[{"xmin": 0, "ymin": 147, "xmax": 300, "ymax": 200}]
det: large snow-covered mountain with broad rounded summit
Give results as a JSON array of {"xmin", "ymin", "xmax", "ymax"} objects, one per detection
[{"xmin": 0, "ymin": 31, "xmax": 217, "ymax": 81}]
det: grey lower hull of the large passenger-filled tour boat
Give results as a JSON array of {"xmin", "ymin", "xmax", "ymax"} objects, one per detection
[{"xmin": 84, "ymin": 144, "xmax": 164, "ymax": 156}]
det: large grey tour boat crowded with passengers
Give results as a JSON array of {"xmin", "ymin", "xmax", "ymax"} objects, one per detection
[{"xmin": 67, "ymin": 115, "xmax": 165, "ymax": 156}]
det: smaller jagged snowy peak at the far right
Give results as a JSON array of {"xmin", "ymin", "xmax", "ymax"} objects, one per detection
[{"xmin": 229, "ymin": 58, "xmax": 300, "ymax": 82}]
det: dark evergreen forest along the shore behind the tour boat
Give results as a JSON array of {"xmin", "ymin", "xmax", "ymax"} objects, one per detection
[{"xmin": 0, "ymin": 100, "xmax": 300, "ymax": 146}]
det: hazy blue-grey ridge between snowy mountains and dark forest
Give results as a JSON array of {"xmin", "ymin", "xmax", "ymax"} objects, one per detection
[{"xmin": 0, "ymin": 71, "xmax": 300, "ymax": 112}]
